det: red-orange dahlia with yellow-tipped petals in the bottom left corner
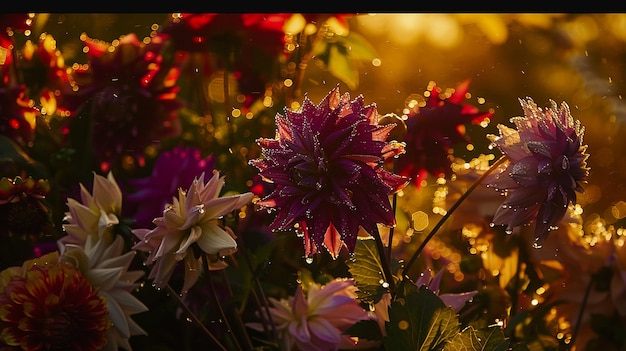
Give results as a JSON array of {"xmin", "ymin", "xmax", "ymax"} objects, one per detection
[{"xmin": 0, "ymin": 252, "xmax": 110, "ymax": 351}]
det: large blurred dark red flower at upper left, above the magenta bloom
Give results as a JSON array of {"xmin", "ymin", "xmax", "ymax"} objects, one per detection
[{"xmin": 68, "ymin": 33, "xmax": 182, "ymax": 172}]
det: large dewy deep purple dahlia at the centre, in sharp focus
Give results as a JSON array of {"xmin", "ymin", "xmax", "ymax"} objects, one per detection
[{"xmin": 250, "ymin": 86, "xmax": 408, "ymax": 257}]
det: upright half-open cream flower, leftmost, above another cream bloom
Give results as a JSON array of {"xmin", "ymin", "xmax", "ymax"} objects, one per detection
[{"xmin": 59, "ymin": 172, "xmax": 122, "ymax": 246}]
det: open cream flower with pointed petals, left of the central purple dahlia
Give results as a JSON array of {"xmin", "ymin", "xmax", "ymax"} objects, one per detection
[{"xmin": 133, "ymin": 171, "xmax": 254, "ymax": 292}]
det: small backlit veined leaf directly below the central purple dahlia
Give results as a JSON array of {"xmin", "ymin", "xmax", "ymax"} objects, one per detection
[{"xmin": 347, "ymin": 238, "xmax": 387, "ymax": 304}]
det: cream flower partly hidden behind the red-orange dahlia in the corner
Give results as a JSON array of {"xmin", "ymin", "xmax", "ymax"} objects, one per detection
[{"xmin": 60, "ymin": 233, "xmax": 148, "ymax": 351}]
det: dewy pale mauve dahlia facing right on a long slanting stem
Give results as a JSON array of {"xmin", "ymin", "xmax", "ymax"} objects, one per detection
[{"xmin": 485, "ymin": 98, "xmax": 589, "ymax": 246}]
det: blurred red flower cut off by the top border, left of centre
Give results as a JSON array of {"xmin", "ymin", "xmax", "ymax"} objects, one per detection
[{"xmin": 159, "ymin": 13, "xmax": 292, "ymax": 107}]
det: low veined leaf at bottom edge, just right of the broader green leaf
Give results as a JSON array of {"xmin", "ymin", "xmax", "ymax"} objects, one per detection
[{"xmin": 443, "ymin": 325, "xmax": 509, "ymax": 351}]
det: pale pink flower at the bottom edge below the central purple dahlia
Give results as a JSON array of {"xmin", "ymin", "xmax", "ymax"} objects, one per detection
[{"xmin": 247, "ymin": 279, "xmax": 370, "ymax": 351}]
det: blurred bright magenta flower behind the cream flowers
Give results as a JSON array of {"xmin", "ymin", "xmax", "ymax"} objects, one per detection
[{"xmin": 125, "ymin": 146, "xmax": 216, "ymax": 228}]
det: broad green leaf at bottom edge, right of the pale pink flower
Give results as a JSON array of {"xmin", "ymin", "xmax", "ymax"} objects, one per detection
[{"xmin": 384, "ymin": 286, "xmax": 459, "ymax": 351}]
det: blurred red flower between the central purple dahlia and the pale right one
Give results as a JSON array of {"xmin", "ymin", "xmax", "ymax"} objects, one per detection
[{"xmin": 397, "ymin": 80, "xmax": 493, "ymax": 187}]
